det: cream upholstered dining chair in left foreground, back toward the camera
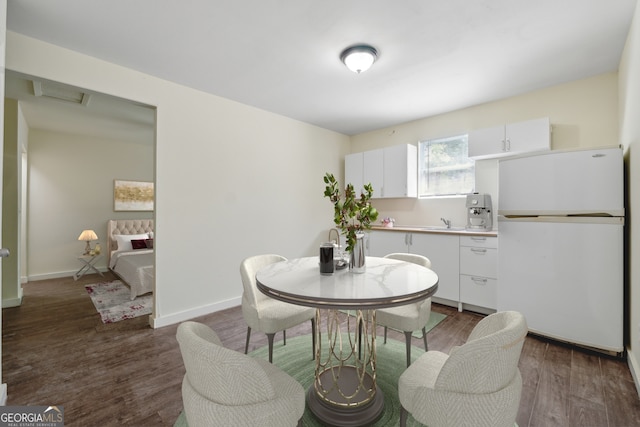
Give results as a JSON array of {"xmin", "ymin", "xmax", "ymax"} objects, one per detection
[{"xmin": 176, "ymin": 322, "xmax": 305, "ymax": 427}]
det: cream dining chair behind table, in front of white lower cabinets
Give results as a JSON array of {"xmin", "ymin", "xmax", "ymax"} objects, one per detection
[{"xmin": 376, "ymin": 253, "xmax": 431, "ymax": 366}]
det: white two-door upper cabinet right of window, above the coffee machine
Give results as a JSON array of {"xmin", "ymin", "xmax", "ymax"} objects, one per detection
[{"xmin": 469, "ymin": 117, "xmax": 551, "ymax": 159}]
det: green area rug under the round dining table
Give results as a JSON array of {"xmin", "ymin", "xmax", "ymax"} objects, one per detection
[{"xmin": 174, "ymin": 335, "xmax": 424, "ymax": 427}]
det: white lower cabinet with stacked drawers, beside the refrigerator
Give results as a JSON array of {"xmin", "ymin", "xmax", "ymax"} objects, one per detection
[{"xmin": 460, "ymin": 236, "xmax": 498, "ymax": 310}]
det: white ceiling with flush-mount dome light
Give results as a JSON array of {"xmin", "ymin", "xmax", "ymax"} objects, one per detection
[{"xmin": 7, "ymin": 0, "xmax": 636, "ymax": 135}]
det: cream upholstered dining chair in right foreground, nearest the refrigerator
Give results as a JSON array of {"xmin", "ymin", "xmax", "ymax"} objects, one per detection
[{"xmin": 398, "ymin": 311, "xmax": 527, "ymax": 427}]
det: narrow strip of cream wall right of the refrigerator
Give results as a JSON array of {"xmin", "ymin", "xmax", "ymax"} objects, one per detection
[{"xmin": 620, "ymin": 0, "xmax": 640, "ymax": 390}]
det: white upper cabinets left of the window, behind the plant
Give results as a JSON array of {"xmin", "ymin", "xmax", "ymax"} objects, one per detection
[{"xmin": 344, "ymin": 144, "xmax": 418, "ymax": 199}]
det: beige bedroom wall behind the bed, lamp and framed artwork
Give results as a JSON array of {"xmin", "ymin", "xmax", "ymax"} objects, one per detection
[{"xmin": 27, "ymin": 129, "xmax": 154, "ymax": 281}]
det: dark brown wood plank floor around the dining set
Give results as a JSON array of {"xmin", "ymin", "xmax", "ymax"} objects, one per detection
[{"xmin": 2, "ymin": 275, "xmax": 640, "ymax": 427}]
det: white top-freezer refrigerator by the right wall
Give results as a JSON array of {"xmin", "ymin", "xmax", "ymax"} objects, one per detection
[{"xmin": 497, "ymin": 147, "xmax": 624, "ymax": 353}]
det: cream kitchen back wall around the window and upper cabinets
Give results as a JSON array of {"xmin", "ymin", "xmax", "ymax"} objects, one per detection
[{"xmin": 351, "ymin": 73, "xmax": 619, "ymax": 226}]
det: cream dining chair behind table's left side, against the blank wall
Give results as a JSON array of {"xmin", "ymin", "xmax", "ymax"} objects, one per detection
[{"xmin": 240, "ymin": 254, "xmax": 316, "ymax": 362}]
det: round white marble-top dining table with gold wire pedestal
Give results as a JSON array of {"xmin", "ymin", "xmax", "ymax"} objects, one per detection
[{"xmin": 256, "ymin": 257, "xmax": 438, "ymax": 426}]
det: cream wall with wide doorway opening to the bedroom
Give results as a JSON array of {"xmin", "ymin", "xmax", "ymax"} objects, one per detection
[{"xmin": 7, "ymin": 32, "xmax": 350, "ymax": 326}]
